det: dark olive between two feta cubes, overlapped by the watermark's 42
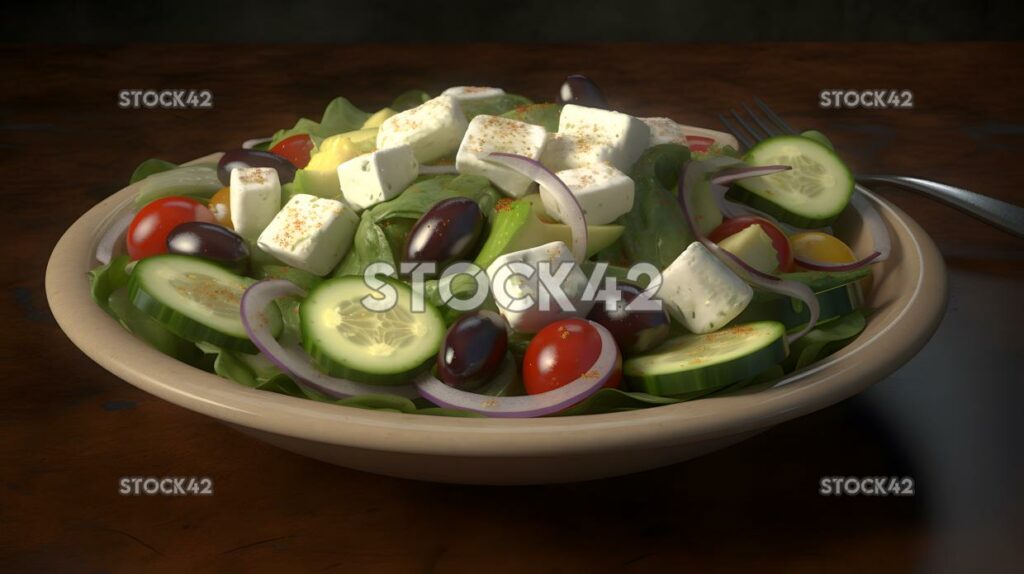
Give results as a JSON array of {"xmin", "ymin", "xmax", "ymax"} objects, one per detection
[{"xmin": 587, "ymin": 282, "xmax": 670, "ymax": 355}]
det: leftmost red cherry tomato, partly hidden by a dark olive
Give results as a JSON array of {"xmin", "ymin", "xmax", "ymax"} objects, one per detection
[{"xmin": 125, "ymin": 196, "xmax": 217, "ymax": 259}]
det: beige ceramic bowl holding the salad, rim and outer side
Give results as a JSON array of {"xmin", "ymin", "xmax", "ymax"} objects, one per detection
[{"xmin": 46, "ymin": 153, "xmax": 946, "ymax": 484}]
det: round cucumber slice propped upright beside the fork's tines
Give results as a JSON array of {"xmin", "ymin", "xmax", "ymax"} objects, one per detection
[{"xmin": 728, "ymin": 136, "xmax": 854, "ymax": 228}]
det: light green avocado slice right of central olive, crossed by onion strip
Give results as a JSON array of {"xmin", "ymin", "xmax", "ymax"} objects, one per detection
[{"xmin": 473, "ymin": 193, "xmax": 625, "ymax": 269}]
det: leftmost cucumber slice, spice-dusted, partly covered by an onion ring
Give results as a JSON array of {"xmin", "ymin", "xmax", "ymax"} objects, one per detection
[{"xmin": 128, "ymin": 255, "xmax": 282, "ymax": 353}]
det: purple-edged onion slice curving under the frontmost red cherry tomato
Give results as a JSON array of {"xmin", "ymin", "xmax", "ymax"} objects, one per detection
[{"xmin": 416, "ymin": 321, "xmax": 618, "ymax": 418}]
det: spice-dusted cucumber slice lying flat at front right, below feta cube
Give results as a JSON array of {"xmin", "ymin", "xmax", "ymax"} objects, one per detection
[{"xmin": 623, "ymin": 321, "xmax": 788, "ymax": 397}]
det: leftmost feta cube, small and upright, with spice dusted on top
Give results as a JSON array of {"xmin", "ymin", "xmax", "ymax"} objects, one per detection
[{"xmin": 228, "ymin": 168, "xmax": 281, "ymax": 239}]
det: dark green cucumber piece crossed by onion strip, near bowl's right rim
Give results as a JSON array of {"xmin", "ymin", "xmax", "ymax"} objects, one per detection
[{"xmin": 734, "ymin": 283, "xmax": 863, "ymax": 329}]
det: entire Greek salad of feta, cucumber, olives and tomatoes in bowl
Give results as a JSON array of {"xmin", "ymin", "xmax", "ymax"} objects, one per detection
[{"xmin": 90, "ymin": 76, "xmax": 889, "ymax": 417}]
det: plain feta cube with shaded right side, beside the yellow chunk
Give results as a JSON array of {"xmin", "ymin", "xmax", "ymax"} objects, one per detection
[{"xmin": 338, "ymin": 145, "xmax": 420, "ymax": 211}]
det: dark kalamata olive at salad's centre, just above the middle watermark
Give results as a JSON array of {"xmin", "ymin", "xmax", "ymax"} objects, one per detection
[{"xmin": 402, "ymin": 197, "xmax": 483, "ymax": 273}]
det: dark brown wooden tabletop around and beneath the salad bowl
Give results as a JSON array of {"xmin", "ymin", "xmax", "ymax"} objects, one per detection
[{"xmin": 6, "ymin": 44, "xmax": 1024, "ymax": 572}]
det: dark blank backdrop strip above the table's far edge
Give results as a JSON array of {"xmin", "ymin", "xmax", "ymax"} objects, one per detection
[{"xmin": 0, "ymin": 0, "xmax": 1022, "ymax": 44}]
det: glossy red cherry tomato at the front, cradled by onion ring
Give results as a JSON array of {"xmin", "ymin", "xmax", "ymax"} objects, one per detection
[{"xmin": 522, "ymin": 319, "xmax": 623, "ymax": 395}]
